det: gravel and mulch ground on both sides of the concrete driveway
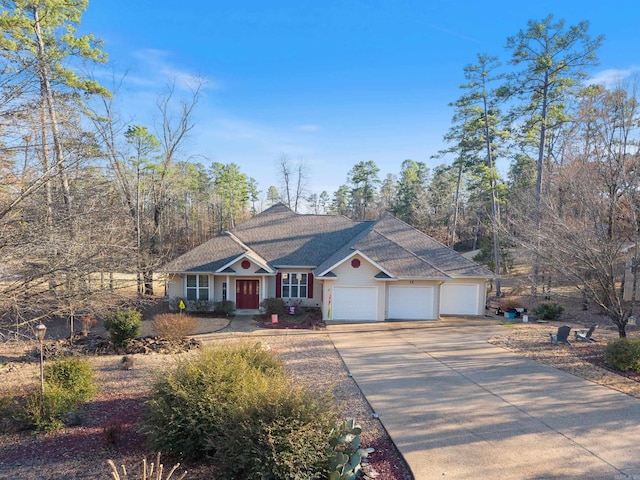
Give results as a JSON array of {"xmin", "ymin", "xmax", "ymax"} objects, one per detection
[{"xmin": 0, "ymin": 309, "xmax": 640, "ymax": 480}]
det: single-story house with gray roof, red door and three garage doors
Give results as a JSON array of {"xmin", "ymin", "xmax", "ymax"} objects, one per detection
[{"xmin": 161, "ymin": 204, "xmax": 493, "ymax": 321}]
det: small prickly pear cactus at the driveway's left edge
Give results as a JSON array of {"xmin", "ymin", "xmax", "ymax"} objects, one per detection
[{"xmin": 328, "ymin": 418, "xmax": 374, "ymax": 480}]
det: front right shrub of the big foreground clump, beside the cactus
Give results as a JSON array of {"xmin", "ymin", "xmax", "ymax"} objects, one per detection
[{"xmin": 214, "ymin": 377, "xmax": 336, "ymax": 480}]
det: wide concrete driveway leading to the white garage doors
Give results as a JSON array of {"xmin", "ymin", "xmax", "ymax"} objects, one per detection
[{"xmin": 329, "ymin": 319, "xmax": 640, "ymax": 480}]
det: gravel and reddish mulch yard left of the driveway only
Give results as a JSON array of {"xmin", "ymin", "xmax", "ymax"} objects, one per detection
[{"xmin": 0, "ymin": 325, "xmax": 413, "ymax": 480}]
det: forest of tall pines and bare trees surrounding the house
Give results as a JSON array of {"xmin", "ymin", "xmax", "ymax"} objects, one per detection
[{"xmin": 0, "ymin": 0, "xmax": 640, "ymax": 335}]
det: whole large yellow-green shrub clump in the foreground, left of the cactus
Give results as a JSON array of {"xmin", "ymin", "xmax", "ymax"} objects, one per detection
[{"xmin": 143, "ymin": 344, "xmax": 336, "ymax": 479}]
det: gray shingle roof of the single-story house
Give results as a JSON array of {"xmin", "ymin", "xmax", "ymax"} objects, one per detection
[{"xmin": 162, "ymin": 204, "xmax": 493, "ymax": 279}]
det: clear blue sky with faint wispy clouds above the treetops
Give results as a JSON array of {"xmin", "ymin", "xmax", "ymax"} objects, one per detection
[{"xmin": 81, "ymin": 0, "xmax": 640, "ymax": 199}]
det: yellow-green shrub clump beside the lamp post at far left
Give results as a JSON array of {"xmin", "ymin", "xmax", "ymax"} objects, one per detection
[{"xmin": 20, "ymin": 357, "xmax": 96, "ymax": 431}]
